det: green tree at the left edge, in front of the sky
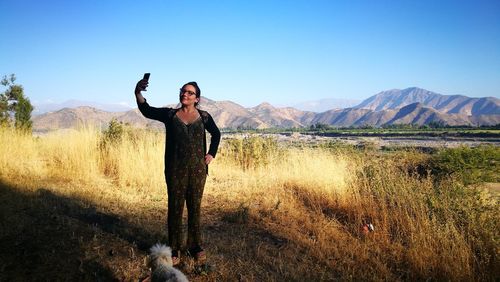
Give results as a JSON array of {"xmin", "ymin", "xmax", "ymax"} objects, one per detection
[{"xmin": 0, "ymin": 74, "xmax": 33, "ymax": 131}]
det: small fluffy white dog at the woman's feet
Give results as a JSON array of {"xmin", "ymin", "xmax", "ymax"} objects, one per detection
[{"xmin": 148, "ymin": 243, "xmax": 188, "ymax": 282}]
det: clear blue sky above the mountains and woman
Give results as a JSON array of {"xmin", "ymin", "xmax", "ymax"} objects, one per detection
[{"xmin": 0, "ymin": 0, "xmax": 500, "ymax": 106}]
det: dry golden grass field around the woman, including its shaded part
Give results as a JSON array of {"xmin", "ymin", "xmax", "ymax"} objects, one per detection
[{"xmin": 0, "ymin": 128, "xmax": 500, "ymax": 281}]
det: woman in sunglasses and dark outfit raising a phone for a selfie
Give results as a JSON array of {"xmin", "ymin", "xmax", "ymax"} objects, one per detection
[{"xmin": 135, "ymin": 76, "xmax": 220, "ymax": 264}]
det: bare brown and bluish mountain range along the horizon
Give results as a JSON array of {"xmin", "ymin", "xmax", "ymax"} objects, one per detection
[{"xmin": 33, "ymin": 87, "xmax": 500, "ymax": 132}]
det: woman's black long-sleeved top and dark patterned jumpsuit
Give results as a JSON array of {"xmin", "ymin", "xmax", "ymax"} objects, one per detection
[{"xmin": 138, "ymin": 102, "xmax": 220, "ymax": 252}]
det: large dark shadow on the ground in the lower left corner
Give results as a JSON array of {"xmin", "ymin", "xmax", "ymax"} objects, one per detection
[{"xmin": 0, "ymin": 179, "xmax": 164, "ymax": 281}]
